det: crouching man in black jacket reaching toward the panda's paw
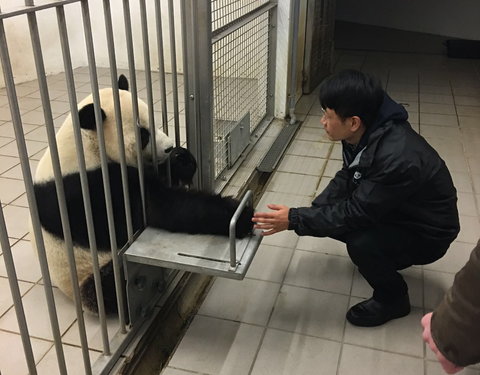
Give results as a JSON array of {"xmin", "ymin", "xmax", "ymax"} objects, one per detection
[{"xmin": 252, "ymin": 70, "xmax": 460, "ymax": 327}]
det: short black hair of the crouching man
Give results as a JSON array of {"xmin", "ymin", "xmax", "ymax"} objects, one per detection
[{"xmin": 320, "ymin": 70, "xmax": 384, "ymax": 127}]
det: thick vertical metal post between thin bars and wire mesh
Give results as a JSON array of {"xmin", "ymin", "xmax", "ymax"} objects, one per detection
[{"xmin": 184, "ymin": 0, "xmax": 215, "ymax": 191}]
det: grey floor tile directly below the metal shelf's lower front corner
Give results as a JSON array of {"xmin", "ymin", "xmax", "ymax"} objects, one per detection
[{"xmin": 199, "ymin": 279, "xmax": 280, "ymax": 325}]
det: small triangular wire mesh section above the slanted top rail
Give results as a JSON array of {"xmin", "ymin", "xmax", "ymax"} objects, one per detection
[{"xmin": 212, "ymin": 0, "xmax": 269, "ymax": 31}]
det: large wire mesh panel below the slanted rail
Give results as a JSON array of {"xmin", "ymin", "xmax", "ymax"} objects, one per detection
[{"xmin": 213, "ymin": 13, "xmax": 269, "ymax": 177}]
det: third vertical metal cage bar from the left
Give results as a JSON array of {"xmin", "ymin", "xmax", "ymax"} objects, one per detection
[{"xmin": 56, "ymin": 4, "xmax": 110, "ymax": 355}]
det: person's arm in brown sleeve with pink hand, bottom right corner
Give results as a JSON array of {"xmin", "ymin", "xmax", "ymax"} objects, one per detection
[{"xmin": 422, "ymin": 241, "xmax": 480, "ymax": 374}]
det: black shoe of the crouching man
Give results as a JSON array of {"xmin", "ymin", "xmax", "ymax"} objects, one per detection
[{"xmin": 347, "ymin": 294, "xmax": 410, "ymax": 327}]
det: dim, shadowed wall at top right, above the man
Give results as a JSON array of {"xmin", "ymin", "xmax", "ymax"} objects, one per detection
[{"xmin": 337, "ymin": 0, "xmax": 480, "ymax": 40}]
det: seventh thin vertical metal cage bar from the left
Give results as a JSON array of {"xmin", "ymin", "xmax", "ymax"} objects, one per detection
[{"xmin": 140, "ymin": 0, "xmax": 158, "ymax": 171}]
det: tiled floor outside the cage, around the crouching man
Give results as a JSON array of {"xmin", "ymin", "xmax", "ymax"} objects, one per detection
[{"xmin": 162, "ymin": 51, "xmax": 480, "ymax": 375}]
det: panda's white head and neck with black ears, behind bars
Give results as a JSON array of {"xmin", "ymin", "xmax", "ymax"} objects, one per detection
[{"xmin": 35, "ymin": 75, "xmax": 174, "ymax": 181}]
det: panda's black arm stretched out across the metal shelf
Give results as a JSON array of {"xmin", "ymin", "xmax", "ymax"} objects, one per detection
[{"xmin": 145, "ymin": 174, "xmax": 253, "ymax": 237}]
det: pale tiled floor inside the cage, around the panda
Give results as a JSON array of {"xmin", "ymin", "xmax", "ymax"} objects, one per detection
[{"xmin": 0, "ymin": 68, "xmax": 187, "ymax": 375}]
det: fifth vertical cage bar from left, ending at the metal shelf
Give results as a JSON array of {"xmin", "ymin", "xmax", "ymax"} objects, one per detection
[{"xmin": 103, "ymin": 0, "xmax": 133, "ymax": 244}]
